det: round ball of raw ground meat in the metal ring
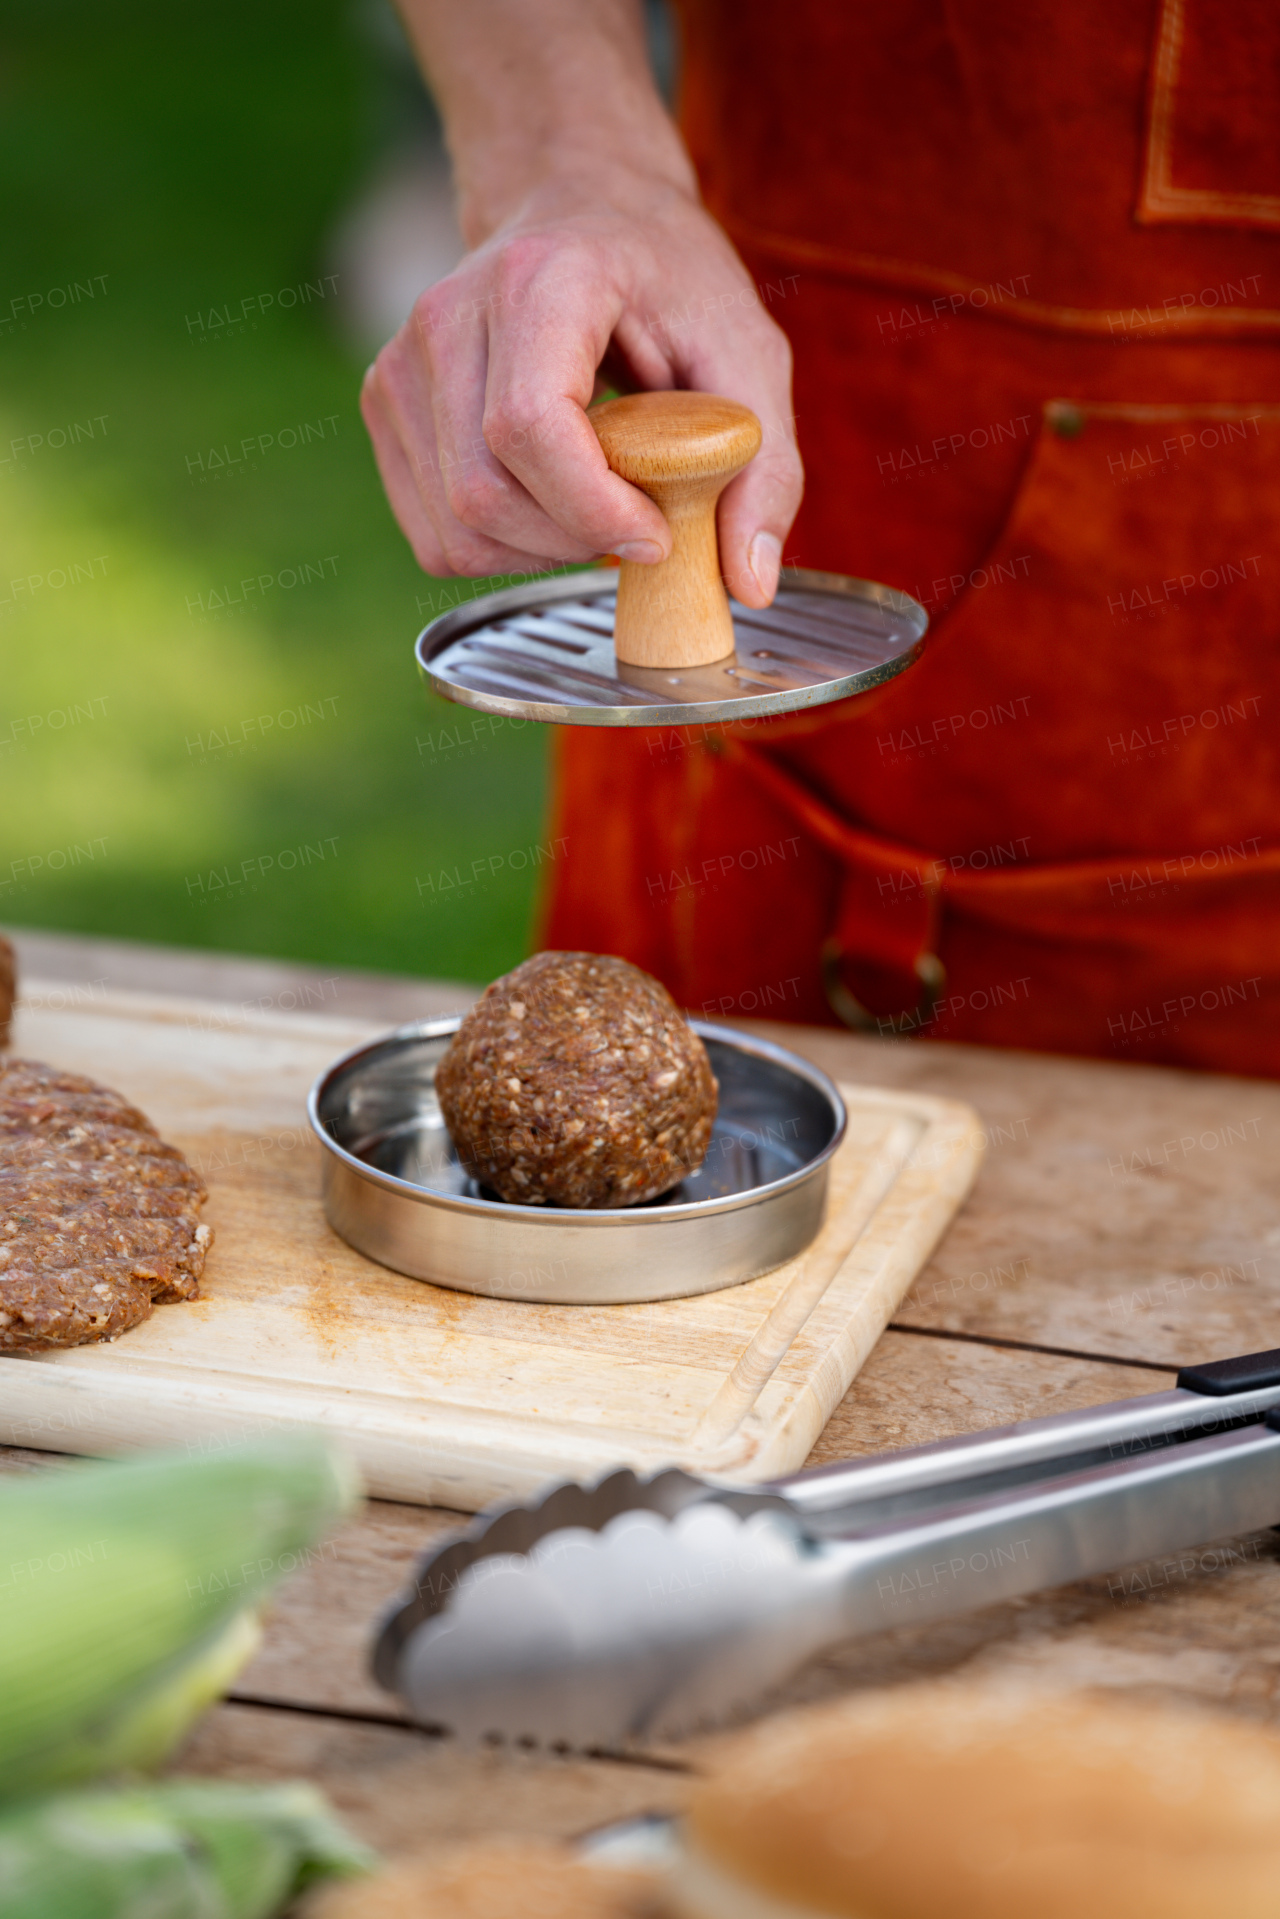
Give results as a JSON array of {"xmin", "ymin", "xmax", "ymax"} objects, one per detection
[{"xmin": 436, "ymin": 954, "xmax": 716, "ymax": 1207}]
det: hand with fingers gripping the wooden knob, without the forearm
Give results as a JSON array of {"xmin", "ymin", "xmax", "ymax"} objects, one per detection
[{"xmin": 361, "ymin": 207, "xmax": 804, "ymax": 591}]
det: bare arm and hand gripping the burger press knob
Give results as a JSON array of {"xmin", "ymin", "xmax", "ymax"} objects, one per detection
[{"xmin": 363, "ymin": 0, "xmax": 802, "ymax": 606}]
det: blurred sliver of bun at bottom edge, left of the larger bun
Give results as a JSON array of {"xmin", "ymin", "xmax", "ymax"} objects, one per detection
[{"xmin": 307, "ymin": 1840, "xmax": 654, "ymax": 1919}]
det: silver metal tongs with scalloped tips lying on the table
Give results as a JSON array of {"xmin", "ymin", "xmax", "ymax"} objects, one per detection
[{"xmin": 372, "ymin": 1351, "xmax": 1280, "ymax": 1750}]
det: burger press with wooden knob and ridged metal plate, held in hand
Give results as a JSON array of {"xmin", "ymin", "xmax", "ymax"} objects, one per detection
[{"xmin": 416, "ymin": 393, "xmax": 929, "ymax": 727}]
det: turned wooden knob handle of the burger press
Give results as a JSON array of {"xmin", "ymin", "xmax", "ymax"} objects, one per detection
[{"xmin": 587, "ymin": 393, "xmax": 762, "ymax": 666}]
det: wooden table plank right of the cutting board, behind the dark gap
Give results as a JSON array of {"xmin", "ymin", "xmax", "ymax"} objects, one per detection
[{"xmin": 760, "ymin": 1025, "xmax": 1280, "ymax": 1368}]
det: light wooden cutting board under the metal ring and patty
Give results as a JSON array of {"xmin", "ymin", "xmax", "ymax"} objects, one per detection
[{"xmin": 0, "ymin": 981, "xmax": 983, "ymax": 1510}]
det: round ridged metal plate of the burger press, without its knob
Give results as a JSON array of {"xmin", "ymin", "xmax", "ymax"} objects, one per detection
[{"xmin": 416, "ymin": 566, "xmax": 929, "ymax": 725}]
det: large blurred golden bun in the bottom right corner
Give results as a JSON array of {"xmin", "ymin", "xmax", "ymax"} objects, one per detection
[{"xmin": 672, "ymin": 1687, "xmax": 1280, "ymax": 1919}]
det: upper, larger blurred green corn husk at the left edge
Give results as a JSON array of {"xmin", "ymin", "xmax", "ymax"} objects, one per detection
[{"xmin": 0, "ymin": 1435, "xmax": 357, "ymax": 1800}]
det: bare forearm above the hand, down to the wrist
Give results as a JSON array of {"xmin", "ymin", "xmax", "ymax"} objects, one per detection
[{"xmin": 397, "ymin": 0, "xmax": 697, "ymax": 246}]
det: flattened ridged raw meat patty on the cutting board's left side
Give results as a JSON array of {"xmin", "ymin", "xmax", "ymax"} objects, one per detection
[{"xmin": 0, "ymin": 1059, "xmax": 213, "ymax": 1353}]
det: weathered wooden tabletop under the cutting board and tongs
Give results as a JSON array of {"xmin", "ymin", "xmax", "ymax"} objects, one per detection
[{"xmin": 10, "ymin": 935, "xmax": 1280, "ymax": 1852}]
